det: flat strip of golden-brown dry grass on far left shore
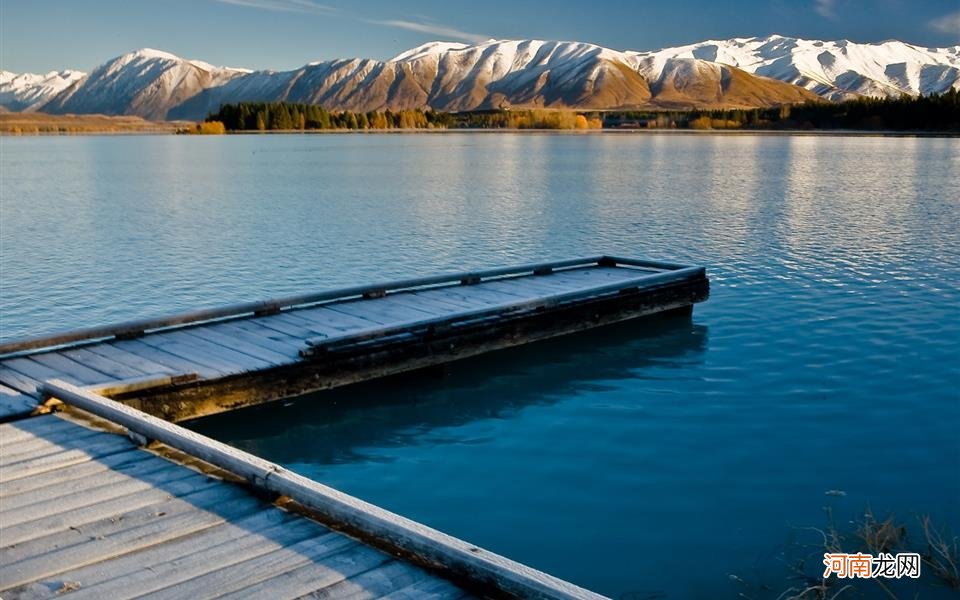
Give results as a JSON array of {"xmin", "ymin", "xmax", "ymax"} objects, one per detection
[{"xmin": 0, "ymin": 112, "xmax": 182, "ymax": 135}]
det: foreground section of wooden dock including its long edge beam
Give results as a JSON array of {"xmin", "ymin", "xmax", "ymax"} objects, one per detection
[{"xmin": 0, "ymin": 380, "xmax": 602, "ymax": 600}]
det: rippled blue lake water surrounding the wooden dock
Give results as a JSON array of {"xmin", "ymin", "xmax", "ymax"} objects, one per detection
[{"xmin": 0, "ymin": 134, "xmax": 960, "ymax": 598}]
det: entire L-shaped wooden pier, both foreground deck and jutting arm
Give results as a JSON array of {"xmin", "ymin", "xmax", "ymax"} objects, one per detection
[{"xmin": 0, "ymin": 256, "xmax": 709, "ymax": 600}]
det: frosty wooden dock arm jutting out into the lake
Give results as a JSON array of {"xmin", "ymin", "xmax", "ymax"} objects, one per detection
[{"xmin": 0, "ymin": 256, "xmax": 709, "ymax": 421}]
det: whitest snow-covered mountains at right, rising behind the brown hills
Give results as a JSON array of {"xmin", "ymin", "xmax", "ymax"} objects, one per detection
[{"xmin": 638, "ymin": 35, "xmax": 960, "ymax": 100}]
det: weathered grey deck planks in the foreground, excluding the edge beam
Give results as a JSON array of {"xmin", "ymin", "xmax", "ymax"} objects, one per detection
[{"xmin": 0, "ymin": 415, "xmax": 474, "ymax": 600}]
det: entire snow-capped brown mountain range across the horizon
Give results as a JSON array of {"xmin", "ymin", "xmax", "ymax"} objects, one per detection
[{"xmin": 0, "ymin": 35, "xmax": 960, "ymax": 120}]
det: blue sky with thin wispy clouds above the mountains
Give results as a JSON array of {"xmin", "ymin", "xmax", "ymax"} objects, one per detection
[{"xmin": 0, "ymin": 0, "xmax": 960, "ymax": 73}]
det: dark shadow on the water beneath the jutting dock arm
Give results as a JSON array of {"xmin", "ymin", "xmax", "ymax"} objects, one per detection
[{"xmin": 188, "ymin": 311, "xmax": 708, "ymax": 464}]
